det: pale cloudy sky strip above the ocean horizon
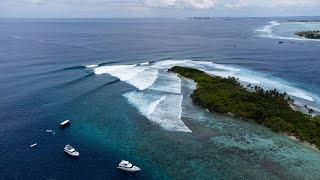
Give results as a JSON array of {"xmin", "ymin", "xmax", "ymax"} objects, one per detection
[{"xmin": 0, "ymin": 0, "xmax": 320, "ymax": 18}]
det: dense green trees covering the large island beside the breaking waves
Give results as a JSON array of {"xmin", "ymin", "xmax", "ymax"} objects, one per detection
[{"xmin": 169, "ymin": 66, "xmax": 320, "ymax": 148}]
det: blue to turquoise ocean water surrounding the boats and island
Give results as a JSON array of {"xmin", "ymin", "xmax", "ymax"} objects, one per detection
[{"xmin": 0, "ymin": 18, "xmax": 320, "ymax": 179}]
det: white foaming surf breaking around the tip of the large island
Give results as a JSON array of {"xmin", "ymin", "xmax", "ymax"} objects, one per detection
[{"xmin": 88, "ymin": 60, "xmax": 319, "ymax": 132}]
